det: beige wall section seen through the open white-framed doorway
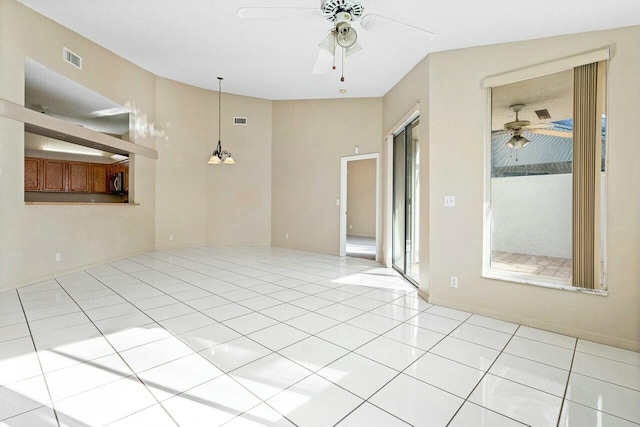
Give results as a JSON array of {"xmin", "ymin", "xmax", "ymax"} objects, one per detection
[{"xmin": 347, "ymin": 159, "xmax": 376, "ymax": 237}]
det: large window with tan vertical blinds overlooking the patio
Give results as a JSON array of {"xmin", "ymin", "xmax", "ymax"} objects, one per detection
[{"xmin": 485, "ymin": 63, "xmax": 606, "ymax": 289}]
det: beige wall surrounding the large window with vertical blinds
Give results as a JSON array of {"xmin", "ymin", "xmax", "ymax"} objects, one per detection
[{"xmin": 385, "ymin": 27, "xmax": 640, "ymax": 350}]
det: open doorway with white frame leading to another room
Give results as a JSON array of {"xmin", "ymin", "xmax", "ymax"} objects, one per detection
[{"xmin": 340, "ymin": 153, "xmax": 380, "ymax": 261}]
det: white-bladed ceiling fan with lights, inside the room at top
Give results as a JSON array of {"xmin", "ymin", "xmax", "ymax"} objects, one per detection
[{"xmin": 238, "ymin": 0, "xmax": 435, "ymax": 82}]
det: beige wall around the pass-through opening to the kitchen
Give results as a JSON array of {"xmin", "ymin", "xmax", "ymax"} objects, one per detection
[{"xmin": 0, "ymin": 0, "xmax": 155, "ymax": 291}]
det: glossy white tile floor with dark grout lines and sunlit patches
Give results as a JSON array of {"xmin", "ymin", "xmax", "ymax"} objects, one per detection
[{"xmin": 0, "ymin": 247, "xmax": 640, "ymax": 427}]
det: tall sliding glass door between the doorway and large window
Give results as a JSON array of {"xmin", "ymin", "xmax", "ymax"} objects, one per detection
[{"xmin": 392, "ymin": 119, "xmax": 420, "ymax": 283}]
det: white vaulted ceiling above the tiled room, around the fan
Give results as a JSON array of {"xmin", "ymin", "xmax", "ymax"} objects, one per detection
[{"xmin": 13, "ymin": 0, "xmax": 640, "ymax": 100}]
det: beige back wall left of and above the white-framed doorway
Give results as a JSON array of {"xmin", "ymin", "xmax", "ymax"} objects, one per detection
[{"xmin": 271, "ymin": 98, "xmax": 382, "ymax": 255}]
